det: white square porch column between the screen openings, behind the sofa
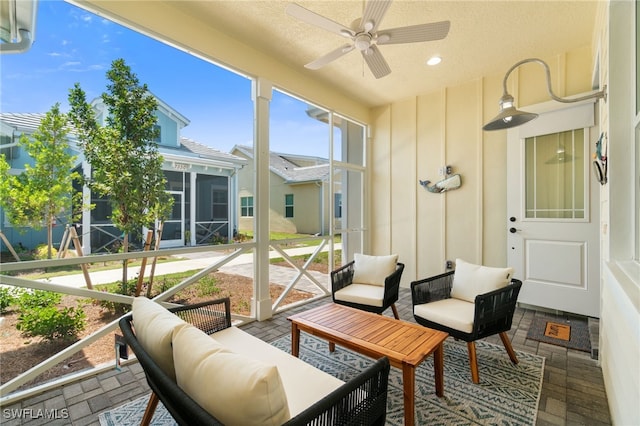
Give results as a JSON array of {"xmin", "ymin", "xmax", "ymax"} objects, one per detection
[{"xmin": 251, "ymin": 78, "xmax": 273, "ymax": 321}]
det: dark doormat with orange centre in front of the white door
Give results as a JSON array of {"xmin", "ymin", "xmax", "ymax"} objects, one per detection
[{"xmin": 527, "ymin": 317, "xmax": 591, "ymax": 352}]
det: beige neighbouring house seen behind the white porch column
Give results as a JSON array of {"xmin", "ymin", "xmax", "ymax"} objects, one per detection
[{"xmin": 231, "ymin": 145, "xmax": 342, "ymax": 235}]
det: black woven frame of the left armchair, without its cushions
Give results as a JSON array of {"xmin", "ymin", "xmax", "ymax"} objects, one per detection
[{"xmin": 331, "ymin": 260, "xmax": 404, "ymax": 319}]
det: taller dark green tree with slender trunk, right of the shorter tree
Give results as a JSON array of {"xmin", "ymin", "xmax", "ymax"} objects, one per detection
[{"xmin": 69, "ymin": 59, "xmax": 173, "ymax": 285}]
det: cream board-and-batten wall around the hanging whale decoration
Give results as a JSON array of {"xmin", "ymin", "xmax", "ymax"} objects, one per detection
[{"xmin": 370, "ymin": 46, "xmax": 594, "ymax": 286}]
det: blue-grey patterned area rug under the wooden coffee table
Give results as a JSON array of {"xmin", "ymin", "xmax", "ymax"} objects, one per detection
[{"xmin": 99, "ymin": 333, "xmax": 545, "ymax": 426}]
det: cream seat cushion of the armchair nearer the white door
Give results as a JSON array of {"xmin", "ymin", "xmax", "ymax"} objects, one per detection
[{"xmin": 413, "ymin": 299, "xmax": 475, "ymax": 333}]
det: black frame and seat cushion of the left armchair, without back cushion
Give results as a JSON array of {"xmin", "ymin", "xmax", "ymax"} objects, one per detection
[{"xmin": 331, "ymin": 260, "xmax": 404, "ymax": 319}]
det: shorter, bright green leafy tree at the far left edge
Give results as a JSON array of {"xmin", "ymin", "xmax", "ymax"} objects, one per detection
[{"xmin": 0, "ymin": 103, "xmax": 82, "ymax": 259}]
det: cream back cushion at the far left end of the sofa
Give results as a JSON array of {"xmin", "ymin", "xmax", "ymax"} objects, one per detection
[{"xmin": 131, "ymin": 297, "xmax": 187, "ymax": 380}]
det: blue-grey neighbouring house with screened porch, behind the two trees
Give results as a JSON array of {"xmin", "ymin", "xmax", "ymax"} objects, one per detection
[{"xmin": 0, "ymin": 98, "xmax": 246, "ymax": 254}]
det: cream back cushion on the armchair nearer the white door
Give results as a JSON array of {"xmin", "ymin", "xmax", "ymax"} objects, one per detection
[{"xmin": 451, "ymin": 259, "xmax": 513, "ymax": 303}]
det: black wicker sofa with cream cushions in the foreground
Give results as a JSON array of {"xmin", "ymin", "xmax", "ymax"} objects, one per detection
[{"xmin": 119, "ymin": 298, "xmax": 389, "ymax": 425}]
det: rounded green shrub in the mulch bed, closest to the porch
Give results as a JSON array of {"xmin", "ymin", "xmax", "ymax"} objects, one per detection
[{"xmin": 16, "ymin": 306, "xmax": 86, "ymax": 340}]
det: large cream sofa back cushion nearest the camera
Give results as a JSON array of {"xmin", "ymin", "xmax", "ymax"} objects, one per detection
[{"xmin": 173, "ymin": 326, "xmax": 290, "ymax": 426}]
